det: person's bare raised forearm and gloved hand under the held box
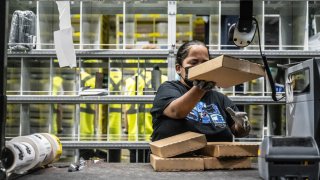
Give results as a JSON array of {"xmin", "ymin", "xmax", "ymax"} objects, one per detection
[{"xmin": 163, "ymin": 80, "xmax": 215, "ymax": 119}]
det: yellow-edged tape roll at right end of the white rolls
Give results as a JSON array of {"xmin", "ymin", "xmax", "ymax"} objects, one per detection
[{"xmin": 41, "ymin": 133, "xmax": 62, "ymax": 163}]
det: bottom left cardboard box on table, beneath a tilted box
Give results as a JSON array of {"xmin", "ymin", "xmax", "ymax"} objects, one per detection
[{"xmin": 150, "ymin": 154, "xmax": 204, "ymax": 171}]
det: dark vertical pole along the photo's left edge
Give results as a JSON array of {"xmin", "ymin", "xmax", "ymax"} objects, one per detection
[{"xmin": 0, "ymin": 0, "xmax": 9, "ymax": 157}]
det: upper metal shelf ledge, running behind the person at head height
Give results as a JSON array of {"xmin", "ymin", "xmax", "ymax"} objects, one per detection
[{"xmin": 8, "ymin": 49, "xmax": 320, "ymax": 58}]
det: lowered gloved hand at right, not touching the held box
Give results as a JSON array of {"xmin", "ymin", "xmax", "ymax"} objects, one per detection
[{"xmin": 226, "ymin": 107, "xmax": 251, "ymax": 137}]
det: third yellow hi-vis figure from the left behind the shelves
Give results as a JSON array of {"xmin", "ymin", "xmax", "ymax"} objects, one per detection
[{"xmin": 108, "ymin": 68, "xmax": 122, "ymax": 162}]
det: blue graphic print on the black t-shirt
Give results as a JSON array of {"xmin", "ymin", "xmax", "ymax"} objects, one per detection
[{"xmin": 186, "ymin": 102, "xmax": 226, "ymax": 128}]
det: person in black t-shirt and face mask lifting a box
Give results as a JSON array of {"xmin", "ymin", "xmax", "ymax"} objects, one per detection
[{"xmin": 150, "ymin": 40, "xmax": 251, "ymax": 141}]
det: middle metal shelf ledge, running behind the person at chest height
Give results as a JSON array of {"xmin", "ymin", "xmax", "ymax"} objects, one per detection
[{"xmin": 7, "ymin": 95, "xmax": 285, "ymax": 105}]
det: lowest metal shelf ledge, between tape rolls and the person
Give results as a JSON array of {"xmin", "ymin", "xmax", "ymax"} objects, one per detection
[{"xmin": 61, "ymin": 141, "xmax": 150, "ymax": 149}]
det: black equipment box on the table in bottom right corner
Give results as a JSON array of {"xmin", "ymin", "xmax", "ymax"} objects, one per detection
[{"xmin": 258, "ymin": 136, "xmax": 320, "ymax": 180}]
